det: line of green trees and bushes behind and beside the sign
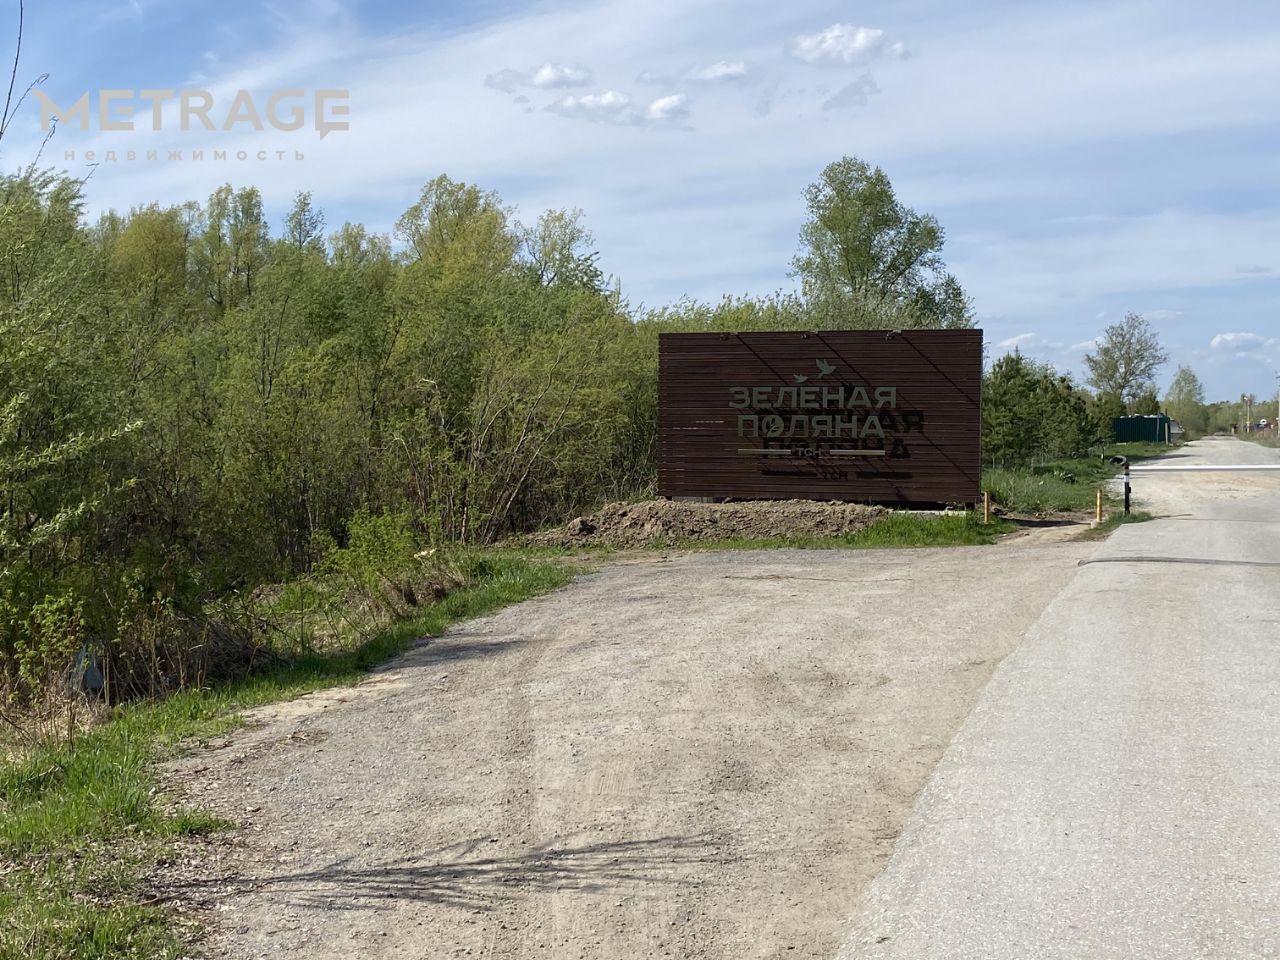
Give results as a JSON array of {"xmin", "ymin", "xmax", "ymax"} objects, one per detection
[{"xmin": 0, "ymin": 157, "xmax": 1244, "ymax": 691}]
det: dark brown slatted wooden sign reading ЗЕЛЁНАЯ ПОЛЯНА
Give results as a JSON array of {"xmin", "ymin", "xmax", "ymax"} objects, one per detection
[{"xmin": 658, "ymin": 330, "xmax": 982, "ymax": 503}]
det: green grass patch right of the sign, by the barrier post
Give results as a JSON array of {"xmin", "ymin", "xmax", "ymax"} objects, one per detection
[{"xmin": 982, "ymin": 443, "xmax": 1172, "ymax": 513}]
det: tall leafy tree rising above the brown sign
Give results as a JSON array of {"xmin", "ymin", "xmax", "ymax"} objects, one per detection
[{"xmin": 792, "ymin": 156, "xmax": 973, "ymax": 326}]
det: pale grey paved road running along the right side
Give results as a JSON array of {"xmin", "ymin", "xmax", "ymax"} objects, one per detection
[{"xmin": 840, "ymin": 439, "xmax": 1280, "ymax": 960}]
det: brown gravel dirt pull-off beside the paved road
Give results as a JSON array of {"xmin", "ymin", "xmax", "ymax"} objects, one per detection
[{"xmin": 167, "ymin": 543, "xmax": 1094, "ymax": 960}]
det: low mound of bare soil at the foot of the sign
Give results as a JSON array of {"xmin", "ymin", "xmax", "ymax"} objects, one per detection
[{"xmin": 531, "ymin": 500, "xmax": 886, "ymax": 547}]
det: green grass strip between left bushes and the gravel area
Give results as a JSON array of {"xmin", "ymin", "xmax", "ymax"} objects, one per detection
[{"xmin": 0, "ymin": 550, "xmax": 575, "ymax": 960}]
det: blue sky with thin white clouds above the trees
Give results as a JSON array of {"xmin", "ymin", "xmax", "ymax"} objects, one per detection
[{"xmin": 0, "ymin": 0, "xmax": 1280, "ymax": 399}]
